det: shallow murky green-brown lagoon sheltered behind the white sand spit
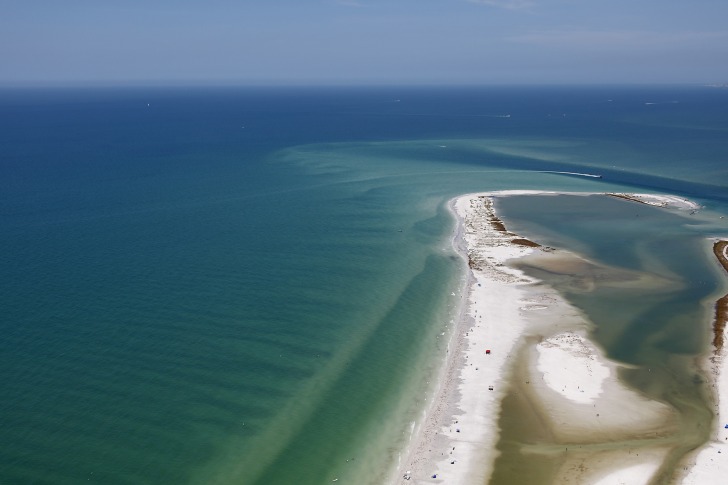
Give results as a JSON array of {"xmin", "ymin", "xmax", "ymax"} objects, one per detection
[{"xmin": 494, "ymin": 195, "xmax": 727, "ymax": 483}]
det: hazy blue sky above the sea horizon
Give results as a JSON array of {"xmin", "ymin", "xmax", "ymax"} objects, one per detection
[{"xmin": 0, "ymin": 0, "xmax": 728, "ymax": 86}]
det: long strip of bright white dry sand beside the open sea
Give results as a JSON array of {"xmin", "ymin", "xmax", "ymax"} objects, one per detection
[{"xmin": 395, "ymin": 196, "xmax": 536, "ymax": 483}]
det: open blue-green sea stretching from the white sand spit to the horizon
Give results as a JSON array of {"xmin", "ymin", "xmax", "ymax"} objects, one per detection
[{"xmin": 0, "ymin": 86, "xmax": 728, "ymax": 484}]
